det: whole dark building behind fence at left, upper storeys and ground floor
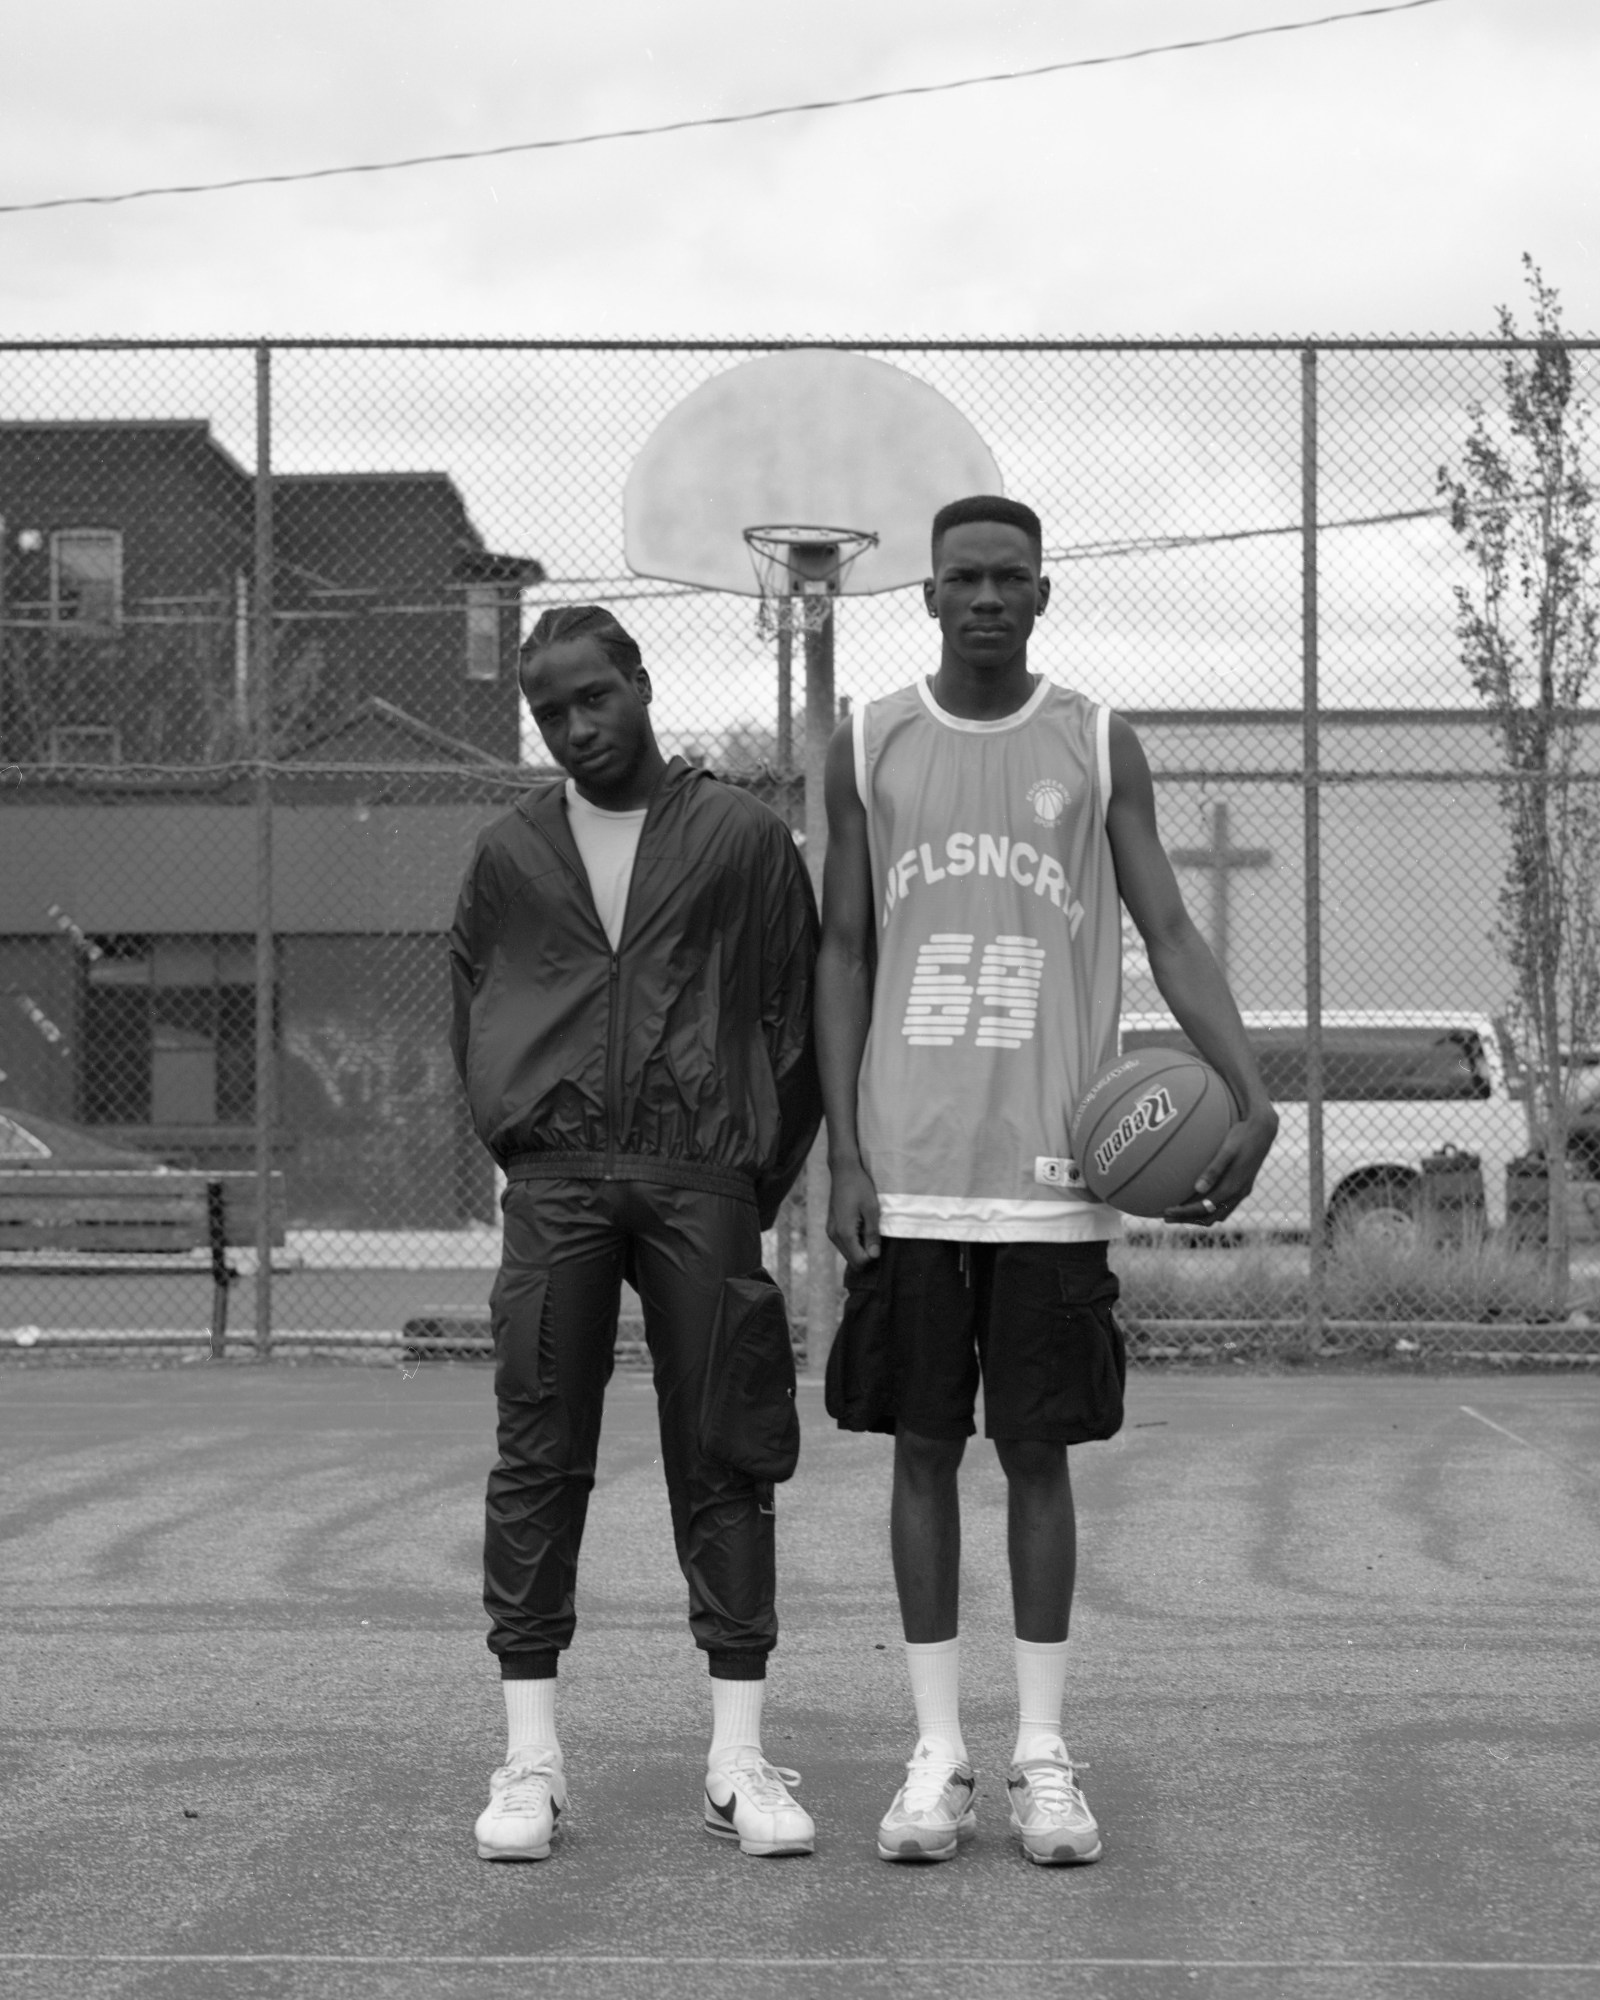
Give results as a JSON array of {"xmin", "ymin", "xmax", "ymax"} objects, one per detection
[{"xmin": 0, "ymin": 422, "xmax": 544, "ymax": 1228}]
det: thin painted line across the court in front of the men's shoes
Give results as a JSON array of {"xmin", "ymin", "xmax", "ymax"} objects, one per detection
[{"xmin": 0, "ymin": 1952, "xmax": 1600, "ymax": 1972}]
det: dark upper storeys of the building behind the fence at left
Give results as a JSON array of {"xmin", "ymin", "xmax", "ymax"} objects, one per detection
[{"xmin": 0, "ymin": 420, "xmax": 544, "ymax": 764}]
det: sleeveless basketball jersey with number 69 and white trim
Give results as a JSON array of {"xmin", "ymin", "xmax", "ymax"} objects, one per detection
[{"xmin": 854, "ymin": 680, "xmax": 1122, "ymax": 1242}]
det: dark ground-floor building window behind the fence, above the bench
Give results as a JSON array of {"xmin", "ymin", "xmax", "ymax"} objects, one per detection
[{"xmin": 78, "ymin": 936, "xmax": 266, "ymax": 1126}]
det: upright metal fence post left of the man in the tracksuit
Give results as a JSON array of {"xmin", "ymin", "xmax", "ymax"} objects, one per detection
[{"xmin": 250, "ymin": 340, "xmax": 278, "ymax": 1360}]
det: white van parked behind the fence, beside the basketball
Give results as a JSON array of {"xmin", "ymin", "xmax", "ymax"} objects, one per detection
[{"xmin": 1122, "ymin": 1008, "xmax": 1530, "ymax": 1236}]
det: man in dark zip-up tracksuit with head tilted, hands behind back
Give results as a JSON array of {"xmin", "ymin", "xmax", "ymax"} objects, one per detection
[{"xmin": 450, "ymin": 606, "xmax": 822, "ymax": 1860}]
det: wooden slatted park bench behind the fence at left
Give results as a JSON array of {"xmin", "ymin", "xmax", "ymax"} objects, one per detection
[{"xmin": 0, "ymin": 1168, "xmax": 288, "ymax": 1356}]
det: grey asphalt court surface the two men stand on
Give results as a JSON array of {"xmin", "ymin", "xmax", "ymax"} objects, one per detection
[{"xmin": 0, "ymin": 1364, "xmax": 1600, "ymax": 2000}]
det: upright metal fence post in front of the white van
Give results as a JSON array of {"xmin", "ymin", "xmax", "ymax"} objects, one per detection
[{"xmin": 1300, "ymin": 346, "xmax": 1328, "ymax": 1346}]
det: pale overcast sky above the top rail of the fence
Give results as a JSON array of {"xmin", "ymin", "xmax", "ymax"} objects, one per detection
[{"xmin": 0, "ymin": 0, "xmax": 1600, "ymax": 336}]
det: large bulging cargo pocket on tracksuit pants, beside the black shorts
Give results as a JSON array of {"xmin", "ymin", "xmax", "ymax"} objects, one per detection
[{"xmin": 700, "ymin": 1270, "xmax": 800, "ymax": 1484}]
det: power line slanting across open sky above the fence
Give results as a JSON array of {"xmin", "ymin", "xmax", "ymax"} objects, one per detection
[{"xmin": 0, "ymin": 0, "xmax": 1442, "ymax": 216}]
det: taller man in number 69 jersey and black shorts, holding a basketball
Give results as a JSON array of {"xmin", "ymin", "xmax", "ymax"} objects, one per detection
[{"xmin": 818, "ymin": 496, "xmax": 1276, "ymax": 1864}]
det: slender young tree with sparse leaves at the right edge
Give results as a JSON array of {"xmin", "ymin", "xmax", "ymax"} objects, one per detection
[{"xmin": 1440, "ymin": 256, "xmax": 1600, "ymax": 1310}]
